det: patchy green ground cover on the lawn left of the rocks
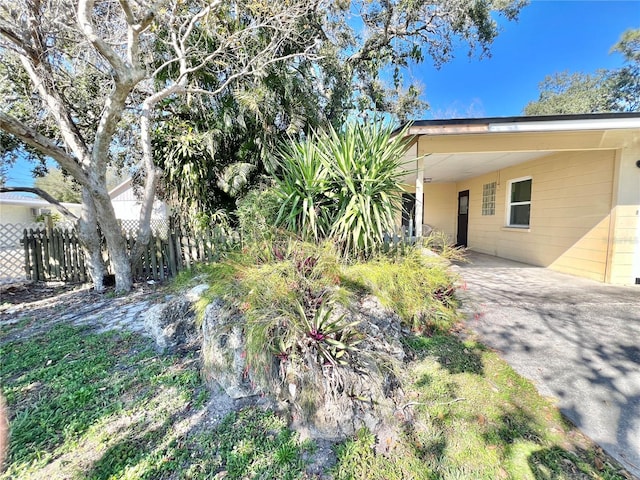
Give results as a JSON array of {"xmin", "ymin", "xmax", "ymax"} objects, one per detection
[{"xmin": 0, "ymin": 323, "xmax": 311, "ymax": 479}]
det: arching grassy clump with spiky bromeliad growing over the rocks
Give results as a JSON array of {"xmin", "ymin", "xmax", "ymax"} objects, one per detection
[{"xmin": 226, "ymin": 241, "xmax": 358, "ymax": 383}]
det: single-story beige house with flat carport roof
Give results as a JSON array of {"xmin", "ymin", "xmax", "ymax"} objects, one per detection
[{"xmin": 403, "ymin": 113, "xmax": 640, "ymax": 284}]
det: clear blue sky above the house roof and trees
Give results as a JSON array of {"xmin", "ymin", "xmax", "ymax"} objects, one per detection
[{"xmin": 2, "ymin": 0, "xmax": 640, "ymax": 185}]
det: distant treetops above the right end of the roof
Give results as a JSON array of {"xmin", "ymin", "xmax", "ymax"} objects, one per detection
[{"xmin": 524, "ymin": 29, "xmax": 640, "ymax": 115}]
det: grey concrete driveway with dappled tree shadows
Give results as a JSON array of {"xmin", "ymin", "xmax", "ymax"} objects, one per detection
[{"xmin": 454, "ymin": 252, "xmax": 640, "ymax": 477}]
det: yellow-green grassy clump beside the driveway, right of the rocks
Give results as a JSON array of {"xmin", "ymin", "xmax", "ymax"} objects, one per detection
[{"xmin": 343, "ymin": 248, "xmax": 458, "ymax": 333}]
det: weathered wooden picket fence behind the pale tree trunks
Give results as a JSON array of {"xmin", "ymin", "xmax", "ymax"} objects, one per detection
[{"xmin": 21, "ymin": 222, "xmax": 237, "ymax": 282}]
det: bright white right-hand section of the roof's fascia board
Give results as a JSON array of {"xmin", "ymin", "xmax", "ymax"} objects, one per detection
[{"xmin": 489, "ymin": 118, "xmax": 640, "ymax": 132}]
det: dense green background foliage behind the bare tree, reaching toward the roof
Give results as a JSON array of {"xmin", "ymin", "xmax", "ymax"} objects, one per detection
[{"xmin": 154, "ymin": 0, "xmax": 526, "ymax": 219}]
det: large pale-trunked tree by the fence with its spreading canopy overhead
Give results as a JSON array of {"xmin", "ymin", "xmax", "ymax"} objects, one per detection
[{"xmin": 0, "ymin": 0, "xmax": 525, "ymax": 290}]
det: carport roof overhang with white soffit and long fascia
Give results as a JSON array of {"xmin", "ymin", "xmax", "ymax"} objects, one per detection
[{"xmin": 403, "ymin": 112, "xmax": 640, "ymax": 184}]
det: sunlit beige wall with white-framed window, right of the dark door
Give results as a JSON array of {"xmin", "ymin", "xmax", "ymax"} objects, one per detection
[{"xmin": 456, "ymin": 150, "xmax": 615, "ymax": 281}]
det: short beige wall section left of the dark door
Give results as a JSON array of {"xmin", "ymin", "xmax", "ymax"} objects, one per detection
[{"xmin": 422, "ymin": 183, "xmax": 458, "ymax": 241}]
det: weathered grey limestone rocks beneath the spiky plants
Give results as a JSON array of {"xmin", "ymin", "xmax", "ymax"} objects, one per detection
[{"xmin": 202, "ymin": 296, "xmax": 406, "ymax": 442}]
